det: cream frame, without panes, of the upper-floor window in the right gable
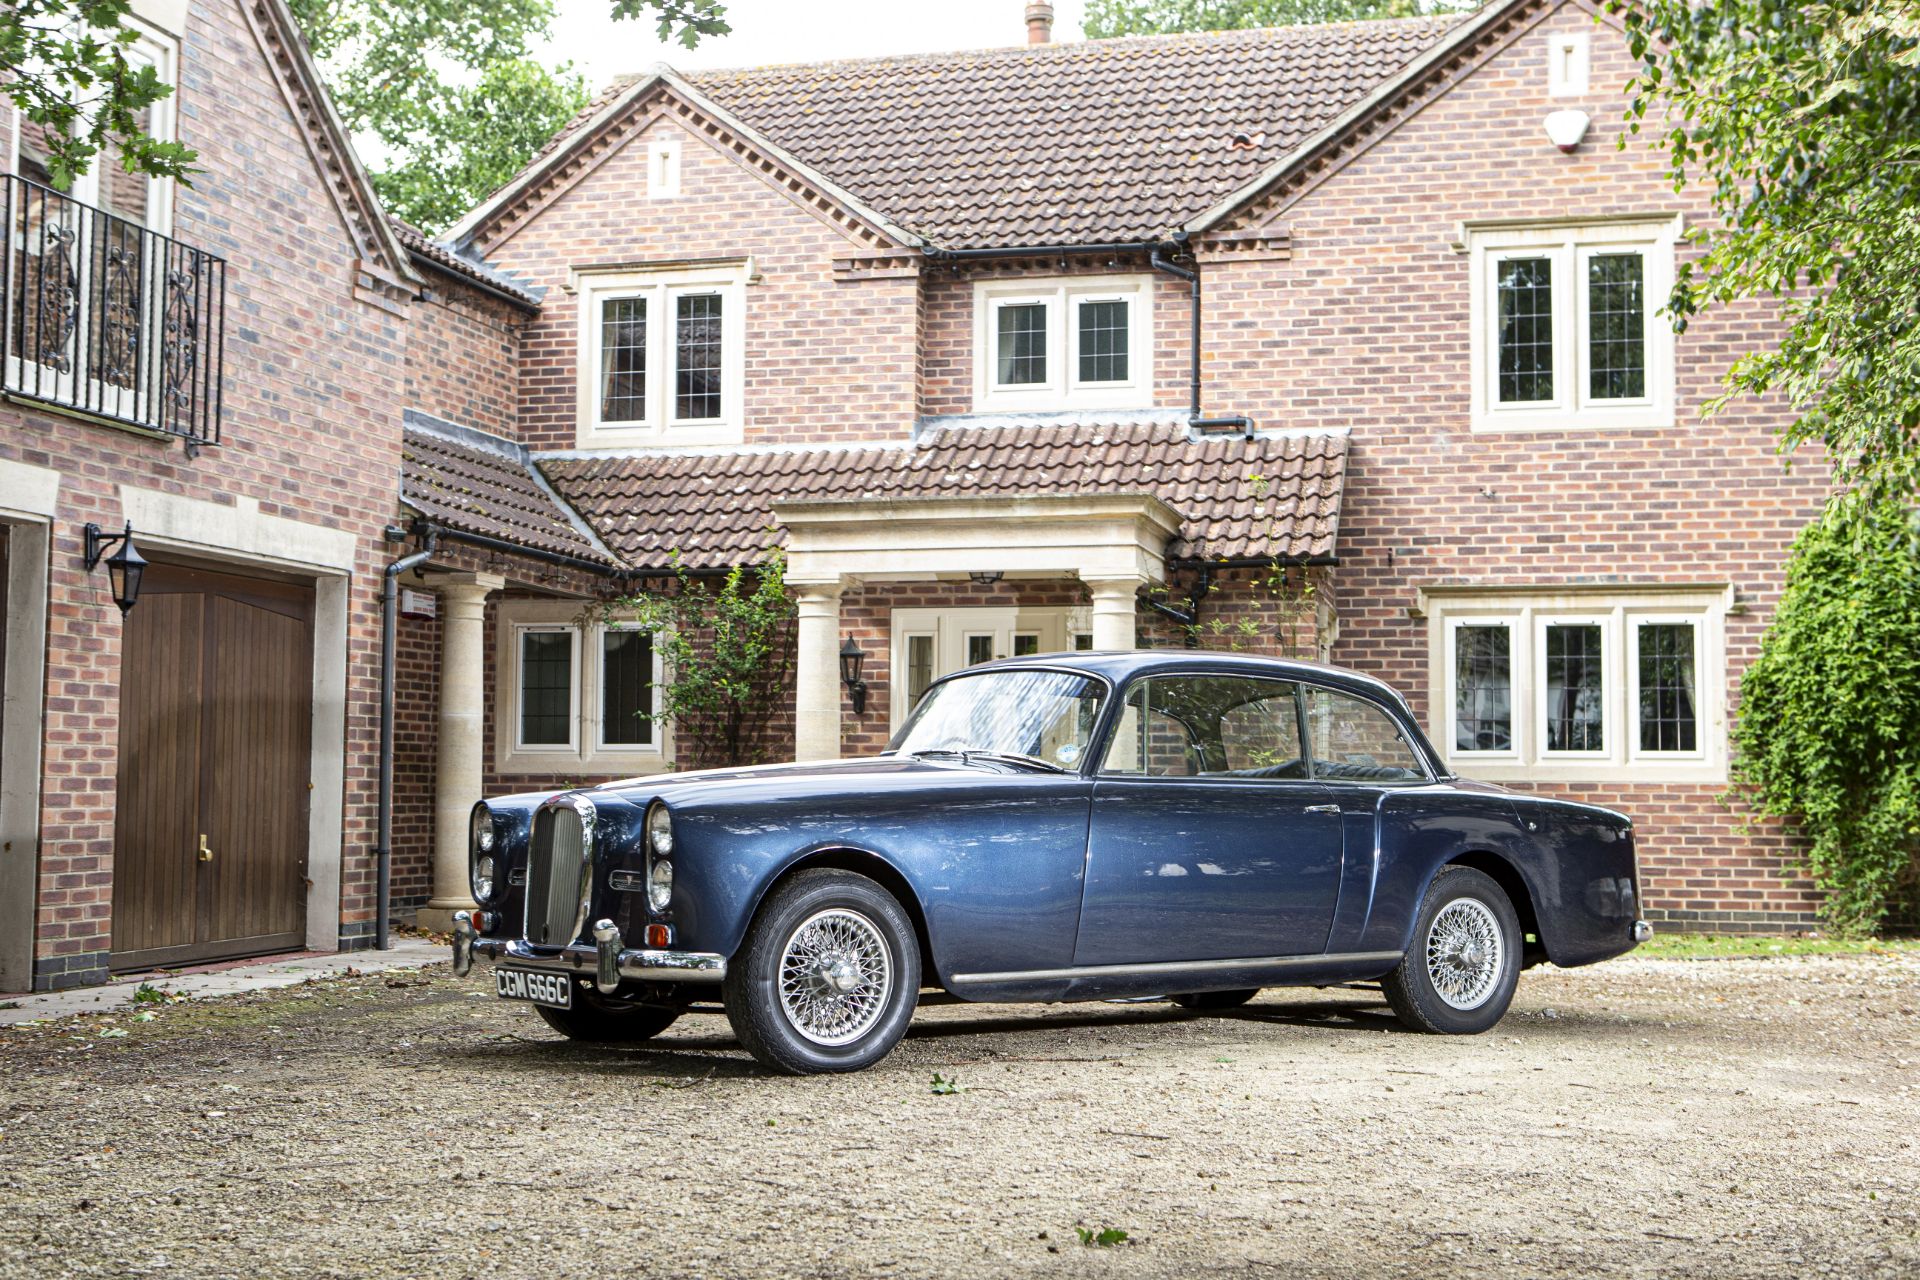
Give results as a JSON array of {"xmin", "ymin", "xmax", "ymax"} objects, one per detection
[{"xmin": 1461, "ymin": 213, "xmax": 1680, "ymax": 432}]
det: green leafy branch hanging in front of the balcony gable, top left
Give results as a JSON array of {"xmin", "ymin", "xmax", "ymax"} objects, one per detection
[{"xmin": 0, "ymin": 0, "xmax": 198, "ymax": 190}]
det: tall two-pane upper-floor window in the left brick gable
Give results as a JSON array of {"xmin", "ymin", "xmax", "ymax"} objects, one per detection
[{"xmin": 578, "ymin": 263, "xmax": 747, "ymax": 449}]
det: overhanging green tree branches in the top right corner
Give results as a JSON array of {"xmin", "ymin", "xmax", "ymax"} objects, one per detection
[{"xmin": 1609, "ymin": 0, "xmax": 1920, "ymax": 491}]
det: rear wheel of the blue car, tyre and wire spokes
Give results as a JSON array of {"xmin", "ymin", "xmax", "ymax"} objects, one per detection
[{"xmin": 1380, "ymin": 865, "xmax": 1521, "ymax": 1036}]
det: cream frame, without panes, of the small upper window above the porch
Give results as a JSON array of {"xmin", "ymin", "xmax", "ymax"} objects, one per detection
[{"xmin": 973, "ymin": 276, "xmax": 1154, "ymax": 413}]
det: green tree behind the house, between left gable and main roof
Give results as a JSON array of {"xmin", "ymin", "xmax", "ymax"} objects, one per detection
[{"xmin": 290, "ymin": 0, "xmax": 728, "ymax": 230}]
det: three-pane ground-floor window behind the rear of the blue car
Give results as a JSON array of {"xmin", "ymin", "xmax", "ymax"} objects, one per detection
[{"xmin": 1423, "ymin": 585, "xmax": 1728, "ymax": 781}]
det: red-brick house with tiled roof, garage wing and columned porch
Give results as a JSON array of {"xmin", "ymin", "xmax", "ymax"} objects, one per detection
[{"xmin": 0, "ymin": 0, "xmax": 1824, "ymax": 990}]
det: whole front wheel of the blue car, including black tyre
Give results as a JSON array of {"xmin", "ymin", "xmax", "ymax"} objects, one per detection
[{"xmin": 722, "ymin": 869, "xmax": 920, "ymax": 1075}]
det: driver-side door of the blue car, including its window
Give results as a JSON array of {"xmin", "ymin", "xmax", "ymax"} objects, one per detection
[{"xmin": 1073, "ymin": 674, "xmax": 1342, "ymax": 965}]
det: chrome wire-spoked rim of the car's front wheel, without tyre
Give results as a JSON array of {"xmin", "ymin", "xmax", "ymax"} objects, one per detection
[{"xmin": 780, "ymin": 908, "xmax": 893, "ymax": 1046}]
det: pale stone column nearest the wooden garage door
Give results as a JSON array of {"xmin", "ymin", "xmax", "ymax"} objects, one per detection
[{"xmin": 415, "ymin": 574, "xmax": 507, "ymax": 933}]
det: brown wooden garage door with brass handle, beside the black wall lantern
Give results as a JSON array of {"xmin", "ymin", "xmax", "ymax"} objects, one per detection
[{"xmin": 113, "ymin": 564, "xmax": 313, "ymax": 969}]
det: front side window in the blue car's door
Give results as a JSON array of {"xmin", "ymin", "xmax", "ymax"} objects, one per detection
[{"xmin": 1104, "ymin": 676, "xmax": 1306, "ymax": 777}]
